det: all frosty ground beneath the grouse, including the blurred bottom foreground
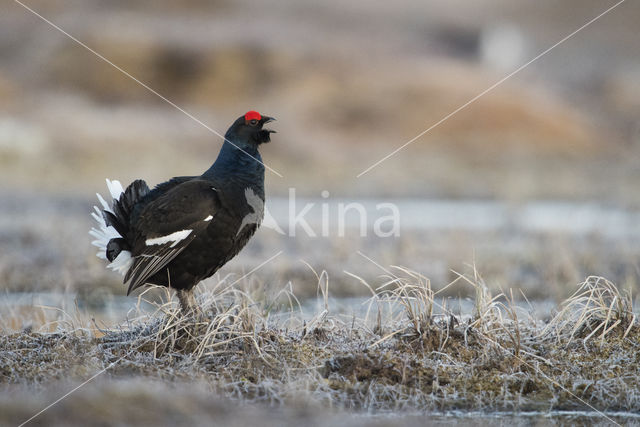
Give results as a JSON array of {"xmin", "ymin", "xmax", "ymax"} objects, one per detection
[{"xmin": 0, "ymin": 276, "xmax": 640, "ymax": 426}]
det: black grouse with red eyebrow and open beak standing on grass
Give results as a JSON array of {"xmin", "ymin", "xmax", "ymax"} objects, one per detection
[{"xmin": 90, "ymin": 111, "xmax": 274, "ymax": 313}]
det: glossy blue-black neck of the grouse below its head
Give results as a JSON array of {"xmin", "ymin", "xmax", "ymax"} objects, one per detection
[{"xmin": 202, "ymin": 141, "xmax": 264, "ymax": 188}]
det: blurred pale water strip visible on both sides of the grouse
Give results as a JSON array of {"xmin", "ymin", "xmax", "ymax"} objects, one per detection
[{"xmin": 5, "ymin": 193, "xmax": 640, "ymax": 238}]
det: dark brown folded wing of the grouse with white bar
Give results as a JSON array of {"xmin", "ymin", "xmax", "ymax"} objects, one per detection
[{"xmin": 124, "ymin": 180, "xmax": 220, "ymax": 294}]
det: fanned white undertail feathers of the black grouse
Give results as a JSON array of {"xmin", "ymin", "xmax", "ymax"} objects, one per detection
[{"xmin": 89, "ymin": 179, "xmax": 133, "ymax": 275}]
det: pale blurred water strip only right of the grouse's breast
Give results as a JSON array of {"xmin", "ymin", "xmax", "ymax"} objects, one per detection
[{"xmin": 266, "ymin": 197, "xmax": 640, "ymax": 238}]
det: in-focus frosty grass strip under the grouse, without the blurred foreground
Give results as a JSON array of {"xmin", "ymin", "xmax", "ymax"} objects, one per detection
[{"xmin": 0, "ymin": 268, "xmax": 640, "ymax": 426}]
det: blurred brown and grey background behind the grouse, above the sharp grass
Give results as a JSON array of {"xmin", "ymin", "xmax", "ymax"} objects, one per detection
[{"xmin": 0, "ymin": 0, "xmax": 640, "ymax": 320}]
